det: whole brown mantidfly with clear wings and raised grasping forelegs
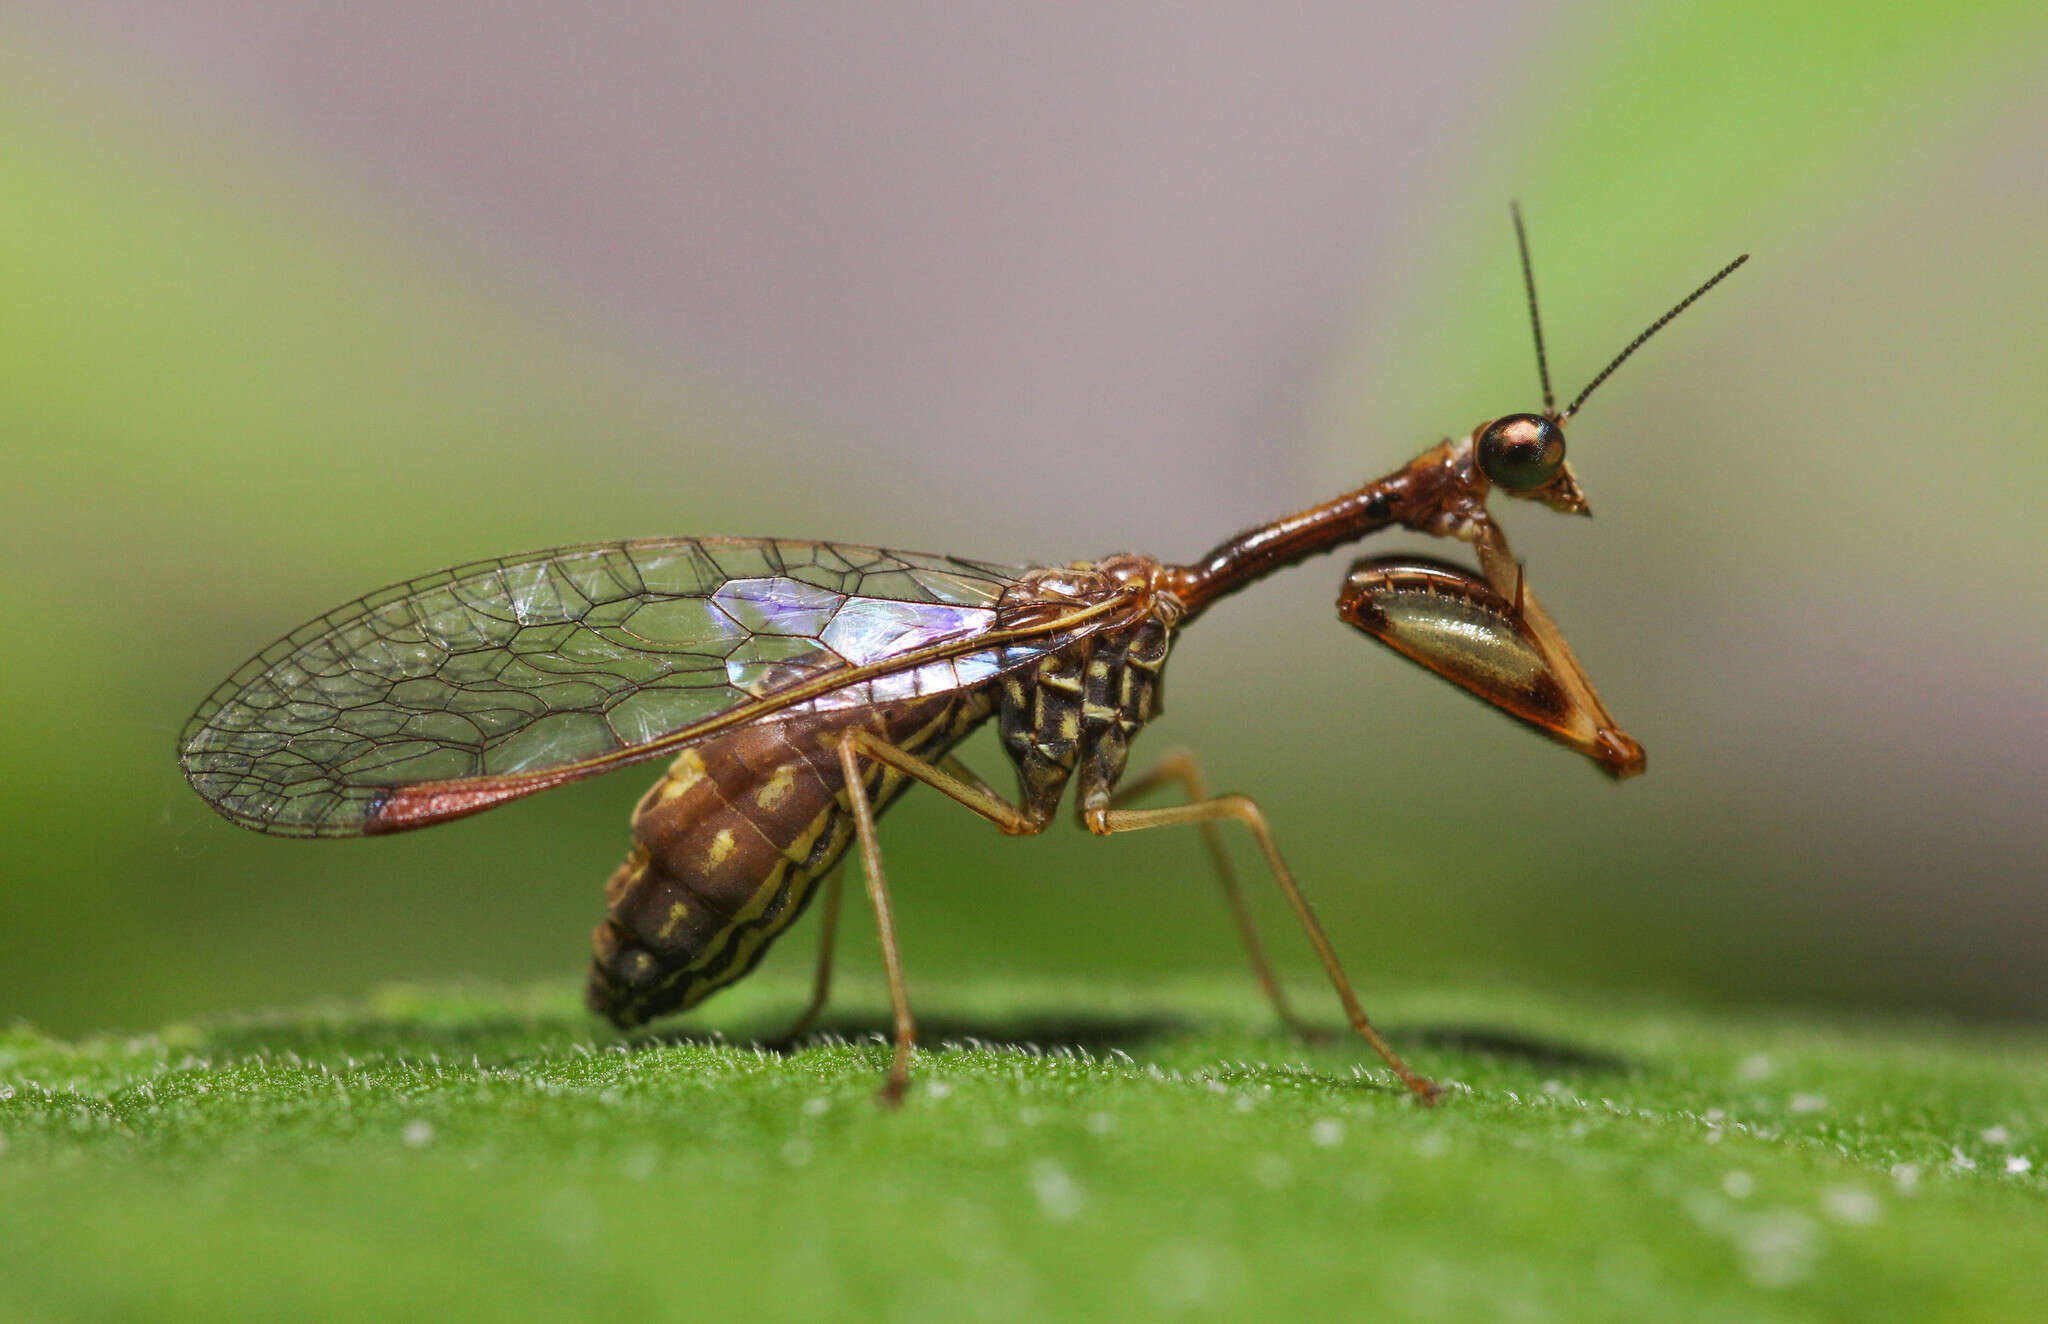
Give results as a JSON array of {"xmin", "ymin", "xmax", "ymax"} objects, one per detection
[{"xmin": 180, "ymin": 215, "xmax": 1741, "ymax": 1101}]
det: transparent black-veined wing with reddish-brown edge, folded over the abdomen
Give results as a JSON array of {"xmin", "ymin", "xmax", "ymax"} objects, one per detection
[{"xmin": 178, "ymin": 539, "xmax": 1051, "ymax": 836}]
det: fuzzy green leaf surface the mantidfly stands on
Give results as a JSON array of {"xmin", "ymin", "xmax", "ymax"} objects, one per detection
[{"xmin": 0, "ymin": 980, "xmax": 2048, "ymax": 1320}]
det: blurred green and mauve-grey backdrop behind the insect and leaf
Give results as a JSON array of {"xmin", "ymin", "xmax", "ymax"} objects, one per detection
[{"xmin": 0, "ymin": 2, "xmax": 2048, "ymax": 1033}]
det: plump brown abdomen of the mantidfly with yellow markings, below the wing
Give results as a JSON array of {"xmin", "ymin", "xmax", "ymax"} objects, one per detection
[{"xmin": 588, "ymin": 693, "xmax": 989, "ymax": 1027}]
